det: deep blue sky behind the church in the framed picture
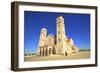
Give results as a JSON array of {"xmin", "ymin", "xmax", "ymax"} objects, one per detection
[{"xmin": 24, "ymin": 11, "xmax": 90, "ymax": 53}]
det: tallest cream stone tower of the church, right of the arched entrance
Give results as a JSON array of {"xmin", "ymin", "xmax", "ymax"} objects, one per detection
[{"xmin": 56, "ymin": 16, "xmax": 66, "ymax": 54}]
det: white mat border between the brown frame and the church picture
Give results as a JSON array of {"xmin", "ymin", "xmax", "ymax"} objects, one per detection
[{"xmin": 18, "ymin": 5, "xmax": 95, "ymax": 68}]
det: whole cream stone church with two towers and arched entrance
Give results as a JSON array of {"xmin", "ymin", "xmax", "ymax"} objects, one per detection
[{"xmin": 37, "ymin": 16, "xmax": 78, "ymax": 56}]
